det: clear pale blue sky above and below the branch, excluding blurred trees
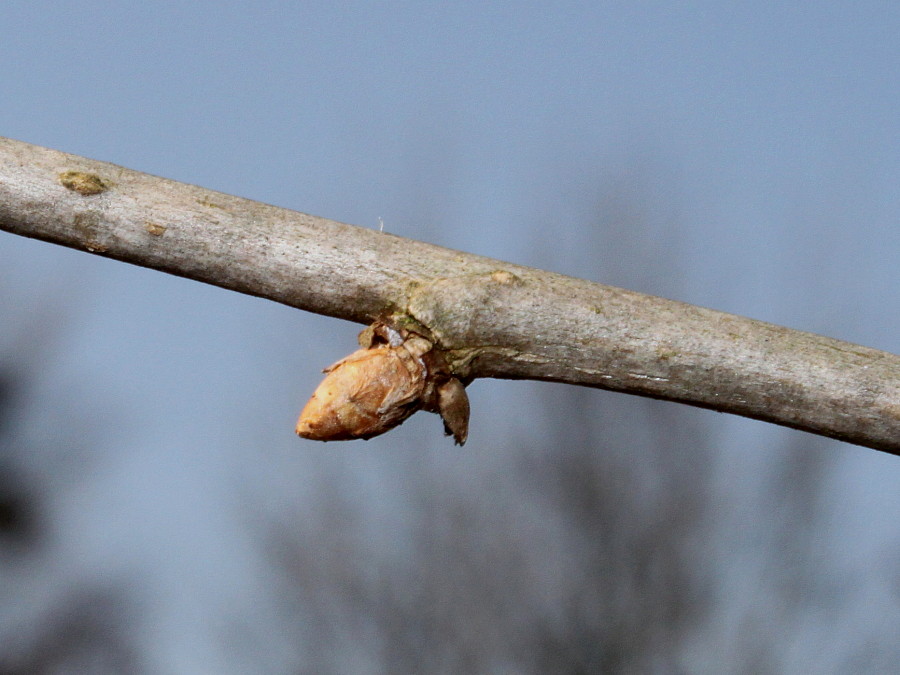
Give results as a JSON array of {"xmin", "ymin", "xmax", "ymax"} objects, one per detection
[{"xmin": 0, "ymin": 0, "xmax": 900, "ymax": 672}]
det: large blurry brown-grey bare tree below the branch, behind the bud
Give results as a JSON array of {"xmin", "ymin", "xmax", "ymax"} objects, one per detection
[{"xmin": 269, "ymin": 352, "xmax": 884, "ymax": 674}]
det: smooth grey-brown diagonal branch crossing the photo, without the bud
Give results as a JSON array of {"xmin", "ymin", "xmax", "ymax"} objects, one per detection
[{"xmin": 0, "ymin": 138, "xmax": 900, "ymax": 455}]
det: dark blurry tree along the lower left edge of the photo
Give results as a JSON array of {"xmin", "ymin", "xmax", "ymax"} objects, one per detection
[{"xmin": 0, "ymin": 302, "xmax": 137, "ymax": 675}]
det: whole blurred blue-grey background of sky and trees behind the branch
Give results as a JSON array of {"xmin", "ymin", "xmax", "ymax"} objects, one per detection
[{"xmin": 0, "ymin": 0, "xmax": 900, "ymax": 675}]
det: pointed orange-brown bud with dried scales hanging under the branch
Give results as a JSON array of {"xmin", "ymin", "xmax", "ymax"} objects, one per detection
[{"xmin": 296, "ymin": 323, "xmax": 469, "ymax": 445}]
